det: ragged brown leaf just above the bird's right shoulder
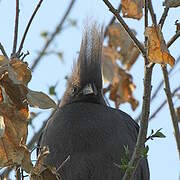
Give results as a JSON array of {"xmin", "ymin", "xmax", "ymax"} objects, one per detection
[{"xmin": 109, "ymin": 67, "xmax": 138, "ymax": 110}]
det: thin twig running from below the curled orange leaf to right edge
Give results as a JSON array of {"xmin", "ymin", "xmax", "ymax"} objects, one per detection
[{"xmin": 162, "ymin": 66, "xmax": 180, "ymax": 158}]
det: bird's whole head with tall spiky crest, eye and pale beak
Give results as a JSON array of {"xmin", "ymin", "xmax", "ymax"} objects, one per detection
[{"xmin": 60, "ymin": 25, "xmax": 105, "ymax": 107}]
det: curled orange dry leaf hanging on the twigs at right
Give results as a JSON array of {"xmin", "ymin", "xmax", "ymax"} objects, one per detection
[{"xmin": 145, "ymin": 26, "xmax": 175, "ymax": 67}]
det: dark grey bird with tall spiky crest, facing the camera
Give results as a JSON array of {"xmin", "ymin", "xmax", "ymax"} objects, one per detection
[{"xmin": 38, "ymin": 23, "xmax": 150, "ymax": 180}]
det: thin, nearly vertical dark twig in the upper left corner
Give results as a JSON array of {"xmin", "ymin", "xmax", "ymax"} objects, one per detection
[{"xmin": 11, "ymin": 0, "xmax": 19, "ymax": 57}]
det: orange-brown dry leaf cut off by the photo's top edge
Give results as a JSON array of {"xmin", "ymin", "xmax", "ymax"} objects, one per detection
[{"xmin": 121, "ymin": 0, "xmax": 143, "ymax": 20}]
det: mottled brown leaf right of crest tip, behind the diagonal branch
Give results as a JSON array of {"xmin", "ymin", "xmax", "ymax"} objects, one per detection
[{"xmin": 108, "ymin": 23, "xmax": 140, "ymax": 70}]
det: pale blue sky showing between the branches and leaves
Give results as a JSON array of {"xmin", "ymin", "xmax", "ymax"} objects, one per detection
[{"xmin": 0, "ymin": 0, "xmax": 180, "ymax": 180}]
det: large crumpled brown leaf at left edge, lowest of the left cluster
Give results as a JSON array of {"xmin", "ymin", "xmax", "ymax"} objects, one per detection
[{"xmin": 0, "ymin": 103, "xmax": 28, "ymax": 170}]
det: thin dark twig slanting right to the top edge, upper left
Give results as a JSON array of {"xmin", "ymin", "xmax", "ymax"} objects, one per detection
[{"xmin": 17, "ymin": 0, "xmax": 43, "ymax": 57}]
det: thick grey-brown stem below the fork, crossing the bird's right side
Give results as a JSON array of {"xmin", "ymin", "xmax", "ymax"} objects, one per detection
[{"xmin": 123, "ymin": 66, "xmax": 153, "ymax": 180}]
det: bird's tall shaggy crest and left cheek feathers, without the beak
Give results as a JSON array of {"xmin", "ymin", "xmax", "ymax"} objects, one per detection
[{"xmin": 60, "ymin": 24, "xmax": 103, "ymax": 106}]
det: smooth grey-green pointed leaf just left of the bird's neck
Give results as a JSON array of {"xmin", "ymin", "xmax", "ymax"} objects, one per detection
[{"xmin": 27, "ymin": 89, "xmax": 57, "ymax": 109}]
